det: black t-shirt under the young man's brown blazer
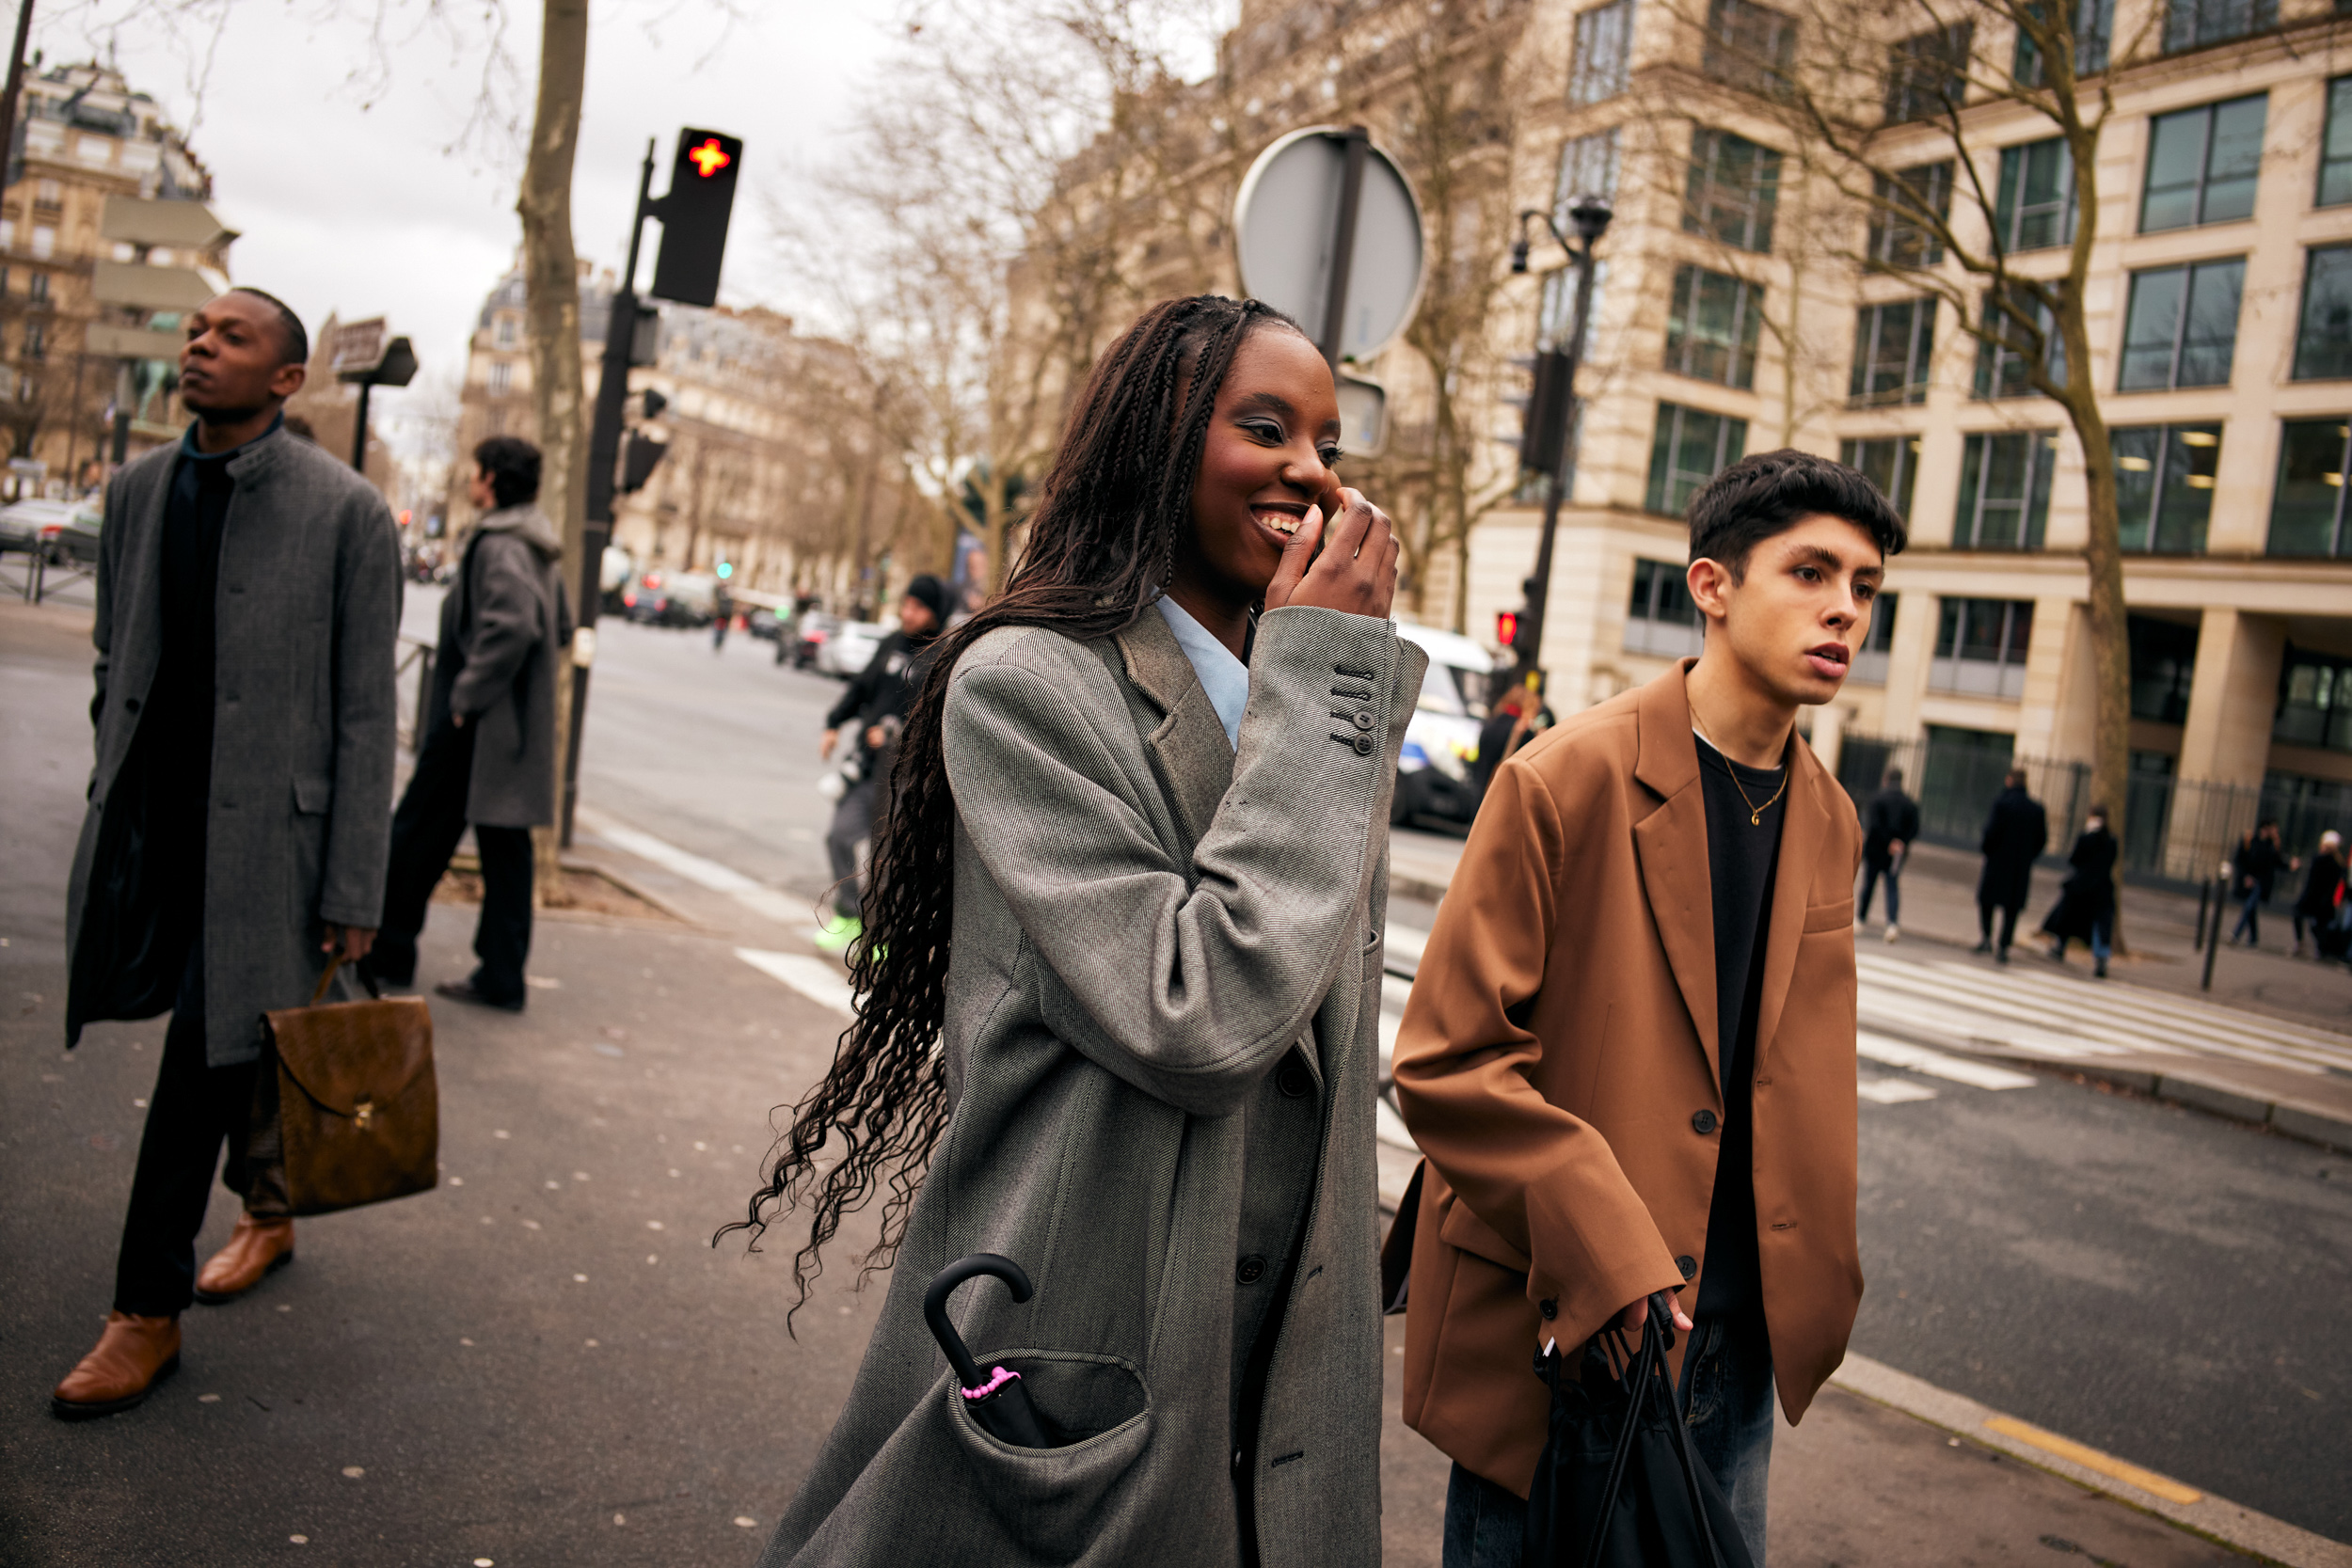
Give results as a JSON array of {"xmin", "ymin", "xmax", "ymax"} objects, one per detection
[{"xmin": 1692, "ymin": 736, "xmax": 1788, "ymax": 1317}]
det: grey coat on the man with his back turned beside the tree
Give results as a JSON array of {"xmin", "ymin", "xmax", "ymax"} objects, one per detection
[{"xmin": 426, "ymin": 503, "xmax": 572, "ymax": 828}]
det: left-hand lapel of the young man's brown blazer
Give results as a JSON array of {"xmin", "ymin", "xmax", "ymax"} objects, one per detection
[{"xmin": 1632, "ymin": 663, "xmax": 1722, "ymax": 1084}]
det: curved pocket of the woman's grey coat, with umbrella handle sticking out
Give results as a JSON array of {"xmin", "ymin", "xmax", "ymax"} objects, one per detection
[{"xmin": 946, "ymin": 1350, "xmax": 1152, "ymax": 1563}]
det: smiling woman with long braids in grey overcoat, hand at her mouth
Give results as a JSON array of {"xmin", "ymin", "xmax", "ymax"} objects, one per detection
[{"xmin": 748, "ymin": 296, "xmax": 1423, "ymax": 1568}]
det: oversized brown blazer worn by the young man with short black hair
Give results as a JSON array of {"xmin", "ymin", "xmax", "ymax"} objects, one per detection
[{"xmin": 1395, "ymin": 665, "xmax": 1863, "ymax": 1496}]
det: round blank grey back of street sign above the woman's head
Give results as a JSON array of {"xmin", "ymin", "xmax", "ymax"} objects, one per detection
[{"xmin": 1232, "ymin": 124, "xmax": 1423, "ymax": 362}]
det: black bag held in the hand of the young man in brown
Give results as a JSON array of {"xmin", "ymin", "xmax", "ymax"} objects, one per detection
[{"xmin": 1522, "ymin": 1295, "xmax": 1755, "ymax": 1568}]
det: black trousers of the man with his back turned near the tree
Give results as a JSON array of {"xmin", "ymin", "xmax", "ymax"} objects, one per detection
[{"xmin": 367, "ymin": 724, "xmax": 532, "ymax": 1002}]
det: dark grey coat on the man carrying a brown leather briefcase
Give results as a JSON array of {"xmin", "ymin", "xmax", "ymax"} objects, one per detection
[{"xmin": 66, "ymin": 428, "xmax": 400, "ymax": 1068}]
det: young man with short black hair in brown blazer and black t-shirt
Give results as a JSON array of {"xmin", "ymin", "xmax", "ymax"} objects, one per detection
[{"xmin": 1395, "ymin": 451, "xmax": 1905, "ymax": 1568}]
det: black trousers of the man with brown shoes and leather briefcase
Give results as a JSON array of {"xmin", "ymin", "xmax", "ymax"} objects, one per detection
[{"xmin": 116, "ymin": 941, "xmax": 287, "ymax": 1317}]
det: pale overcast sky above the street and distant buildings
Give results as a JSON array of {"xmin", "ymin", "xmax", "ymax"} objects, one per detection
[{"xmin": 33, "ymin": 0, "xmax": 898, "ymax": 453}]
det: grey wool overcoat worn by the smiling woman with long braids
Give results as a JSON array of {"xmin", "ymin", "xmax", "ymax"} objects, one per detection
[{"xmin": 762, "ymin": 609, "xmax": 1425, "ymax": 1568}]
